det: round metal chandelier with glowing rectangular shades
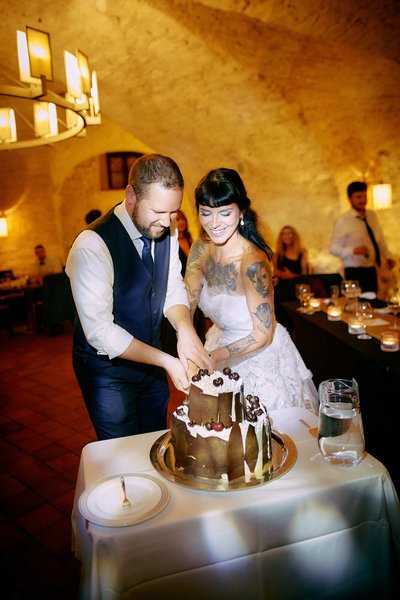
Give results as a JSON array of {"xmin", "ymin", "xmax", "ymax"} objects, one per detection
[{"xmin": 0, "ymin": 27, "xmax": 101, "ymax": 150}]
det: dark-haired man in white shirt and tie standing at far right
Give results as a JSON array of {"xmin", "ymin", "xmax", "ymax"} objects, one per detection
[{"xmin": 330, "ymin": 181, "xmax": 395, "ymax": 292}]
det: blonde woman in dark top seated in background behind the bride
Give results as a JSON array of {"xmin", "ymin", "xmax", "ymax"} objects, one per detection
[{"xmin": 274, "ymin": 225, "xmax": 308, "ymax": 279}]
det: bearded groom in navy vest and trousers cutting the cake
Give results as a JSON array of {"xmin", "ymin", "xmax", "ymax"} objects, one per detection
[{"xmin": 66, "ymin": 154, "xmax": 213, "ymax": 439}]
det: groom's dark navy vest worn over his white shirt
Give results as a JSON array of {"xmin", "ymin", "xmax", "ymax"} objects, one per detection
[{"xmin": 74, "ymin": 209, "xmax": 170, "ymax": 381}]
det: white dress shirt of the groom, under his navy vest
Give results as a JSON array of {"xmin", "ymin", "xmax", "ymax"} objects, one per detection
[{"xmin": 65, "ymin": 201, "xmax": 189, "ymax": 359}]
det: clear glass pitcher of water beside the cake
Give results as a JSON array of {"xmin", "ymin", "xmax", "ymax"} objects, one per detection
[{"xmin": 318, "ymin": 379, "xmax": 365, "ymax": 466}]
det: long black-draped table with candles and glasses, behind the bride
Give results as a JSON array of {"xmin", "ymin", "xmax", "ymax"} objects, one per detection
[{"xmin": 282, "ymin": 302, "xmax": 400, "ymax": 492}]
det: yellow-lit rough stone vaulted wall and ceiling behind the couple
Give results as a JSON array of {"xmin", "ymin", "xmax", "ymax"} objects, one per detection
[{"xmin": 0, "ymin": 0, "xmax": 400, "ymax": 288}]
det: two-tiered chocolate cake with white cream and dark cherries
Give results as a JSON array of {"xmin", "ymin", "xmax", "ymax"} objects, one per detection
[{"xmin": 168, "ymin": 367, "xmax": 272, "ymax": 481}]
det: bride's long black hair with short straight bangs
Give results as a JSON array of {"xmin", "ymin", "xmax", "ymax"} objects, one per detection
[{"xmin": 195, "ymin": 167, "xmax": 272, "ymax": 260}]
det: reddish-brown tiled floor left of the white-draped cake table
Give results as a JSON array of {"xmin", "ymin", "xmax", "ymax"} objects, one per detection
[{"xmin": 0, "ymin": 325, "xmax": 184, "ymax": 600}]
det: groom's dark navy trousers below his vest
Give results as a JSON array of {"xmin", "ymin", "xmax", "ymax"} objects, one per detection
[{"xmin": 73, "ymin": 357, "xmax": 169, "ymax": 440}]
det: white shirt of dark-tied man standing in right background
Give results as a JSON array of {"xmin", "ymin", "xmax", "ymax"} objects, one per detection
[{"xmin": 330, "ymin": 208, "xmax": 390, "ymax": 267}]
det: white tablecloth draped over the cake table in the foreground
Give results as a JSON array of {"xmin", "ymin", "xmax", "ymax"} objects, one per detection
[{"xmin": 72, "ymin": 408, "xmax": 400, "ymax": 600}]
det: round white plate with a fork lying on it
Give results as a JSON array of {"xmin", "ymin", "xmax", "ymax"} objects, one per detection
[{"xmin": 78, "ymin": 473, "xmax": 170, "ymax": 527}]
